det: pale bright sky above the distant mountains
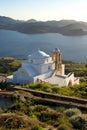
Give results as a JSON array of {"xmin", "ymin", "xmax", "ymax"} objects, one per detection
[{"xmin": 0, "ymin": 0, "xmax": 87, "ymax": 22}]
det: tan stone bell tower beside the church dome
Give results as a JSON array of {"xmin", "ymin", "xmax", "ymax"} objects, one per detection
[{"xmin": 52, "ymin": 48, "xmax": 62, "ymax": 75}]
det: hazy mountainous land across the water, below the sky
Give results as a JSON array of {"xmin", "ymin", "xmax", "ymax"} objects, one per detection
[{"xmin": 0, "ymin": 16, "xmax": 87, "ymax": 36}]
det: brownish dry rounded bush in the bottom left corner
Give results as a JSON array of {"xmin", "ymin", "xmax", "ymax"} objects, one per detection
[{"xmin": 0, "ymin": 113, "xmax": 28, "ymax": 129}]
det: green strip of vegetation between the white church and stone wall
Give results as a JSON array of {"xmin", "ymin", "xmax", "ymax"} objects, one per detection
[{"xmin": 23, "ymin": 82, "xmax": 87, "ymax": 99}]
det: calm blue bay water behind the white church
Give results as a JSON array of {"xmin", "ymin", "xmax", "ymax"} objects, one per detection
[{"xmin": 0, "ymin": 30, "xmax": 87, "ymax": 63}]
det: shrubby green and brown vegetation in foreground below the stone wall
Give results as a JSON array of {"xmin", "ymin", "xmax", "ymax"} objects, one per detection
[{"xmin": 0, "ymin": 91, "xmax": 87, "ymax": 130}]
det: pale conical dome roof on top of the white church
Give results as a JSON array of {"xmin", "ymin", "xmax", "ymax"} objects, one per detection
[{"xmin": 28, "ymin": 50, "xmax": 50, "ymax": 59}]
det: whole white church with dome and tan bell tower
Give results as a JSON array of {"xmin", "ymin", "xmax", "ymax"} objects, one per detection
[{"xmin": 7, "ymin": 48, "xmax": 79, "ymax": 86}]
